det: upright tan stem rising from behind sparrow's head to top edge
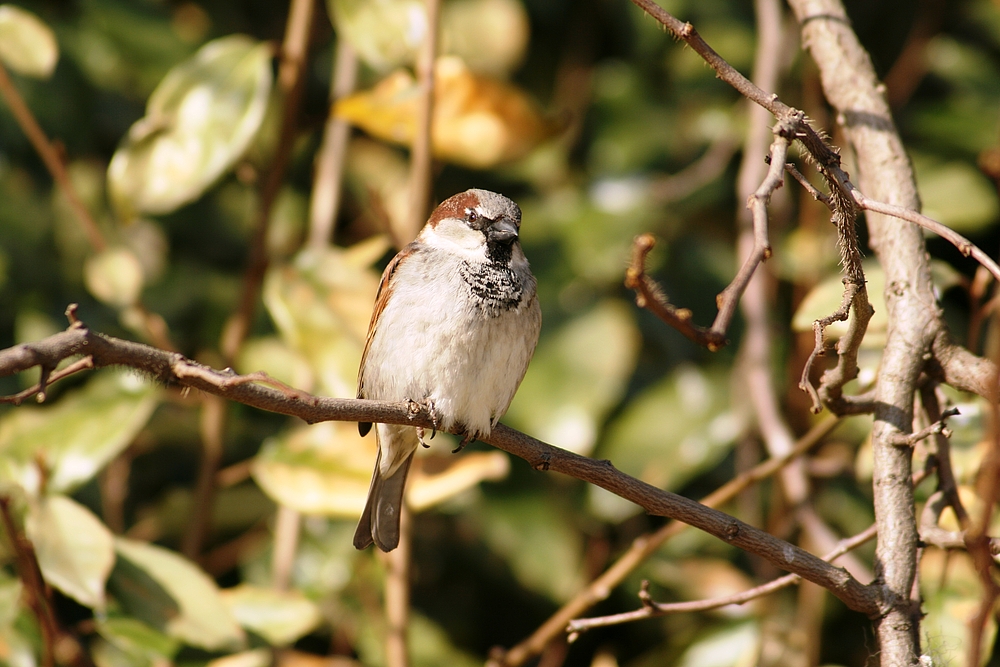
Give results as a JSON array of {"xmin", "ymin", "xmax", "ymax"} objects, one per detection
[{"xmin": 405, "ymin": 0, "xmax": 441, "ymax": 242}]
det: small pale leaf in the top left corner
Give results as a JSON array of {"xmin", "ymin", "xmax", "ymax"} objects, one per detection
[{"xmin": 0, "ymin": 5, "xmax": 59, "ymax": 79}]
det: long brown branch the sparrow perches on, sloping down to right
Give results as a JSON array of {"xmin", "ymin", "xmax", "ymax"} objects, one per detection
[{"xmin": 0, "ymin": 323, "xmax": 882, "ymax": 615}]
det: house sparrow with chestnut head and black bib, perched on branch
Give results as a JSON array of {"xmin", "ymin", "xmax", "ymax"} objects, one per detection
[{"xmin": 354, "ymin": 190, "xmax": 542, "ymax": 551}]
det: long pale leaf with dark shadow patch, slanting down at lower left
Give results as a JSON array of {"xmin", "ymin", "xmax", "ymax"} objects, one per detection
[{"xmin": 112, "ymin": 538, "xmax": 245, "ymax": 651}]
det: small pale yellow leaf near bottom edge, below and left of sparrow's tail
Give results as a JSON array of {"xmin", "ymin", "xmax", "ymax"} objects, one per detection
[{"xmin": 222, "ymin": 584, "xmax": 322, "ymax": 646}]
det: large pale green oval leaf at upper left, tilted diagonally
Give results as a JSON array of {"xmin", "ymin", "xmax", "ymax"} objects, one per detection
[{"xmin": 108, "ymin": 35, "xmax": 272, "ymax": 220}]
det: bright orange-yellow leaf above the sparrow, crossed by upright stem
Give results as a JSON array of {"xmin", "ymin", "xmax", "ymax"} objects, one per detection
[{"xmin": 336, "ymin": 56, "xmax": 557, "ymax": 169}]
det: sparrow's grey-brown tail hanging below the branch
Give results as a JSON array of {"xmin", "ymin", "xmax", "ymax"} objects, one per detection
[{"xmin": 354, "ymin": 424, "xmax": 419, "ymax": 551}]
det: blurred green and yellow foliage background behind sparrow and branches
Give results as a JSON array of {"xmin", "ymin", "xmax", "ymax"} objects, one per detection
[{"xmin": 0, "ymin": 0, "xmax": 1000, "ymax": 667}]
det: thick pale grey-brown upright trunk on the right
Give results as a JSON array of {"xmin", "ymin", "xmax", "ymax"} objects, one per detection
[{"xmin": 789, "ymin": 0, "xmax": 941, "ymax": 665}]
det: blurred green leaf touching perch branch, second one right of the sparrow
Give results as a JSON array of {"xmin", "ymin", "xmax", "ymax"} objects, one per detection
[{"xmin": 588, "ymin": 366, "xmax": 742, "ymax": 520}]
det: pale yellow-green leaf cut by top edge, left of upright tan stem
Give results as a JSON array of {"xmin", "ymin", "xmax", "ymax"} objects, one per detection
[{"xmin": 326, "ymin": 0, "xmax": 427, "ymax": 70}]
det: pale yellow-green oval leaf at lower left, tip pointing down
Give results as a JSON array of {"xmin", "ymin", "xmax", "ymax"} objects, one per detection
[{"xmin": 25, "ymin": 496, "xmax": 115, "ymax": 609}]
